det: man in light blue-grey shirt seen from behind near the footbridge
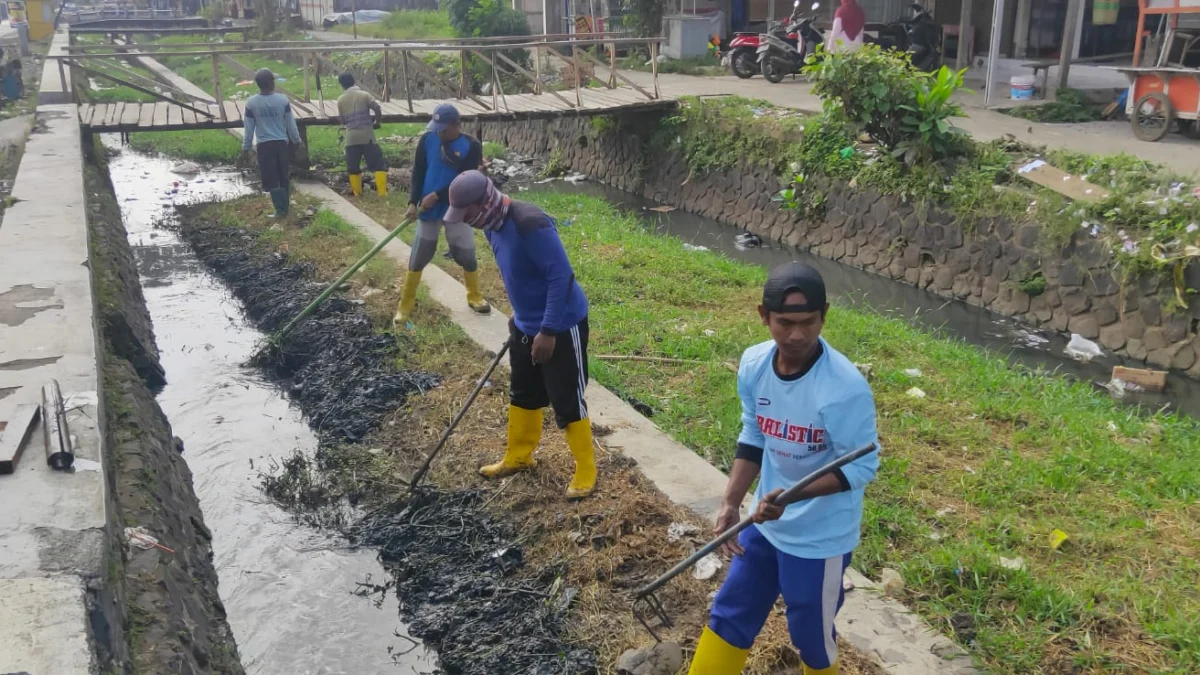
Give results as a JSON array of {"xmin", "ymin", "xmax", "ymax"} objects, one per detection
[{"xmin": 241, "ymin": 68, "xmax": 300, "ymax": 219}]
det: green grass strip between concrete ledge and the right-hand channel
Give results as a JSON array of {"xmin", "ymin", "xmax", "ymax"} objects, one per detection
[{"xmin": 336, "ymin": 182, "xmax": 1200, "ymax": 673}]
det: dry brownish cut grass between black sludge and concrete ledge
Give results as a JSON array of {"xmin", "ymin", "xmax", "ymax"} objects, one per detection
[{"xmin": 182, "ymin": 190, "xmax": 878, "ymax": 675}]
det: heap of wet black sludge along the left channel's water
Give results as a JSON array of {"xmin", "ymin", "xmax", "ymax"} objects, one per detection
[{"xmin": 181, "ymin": 209, "xmax": 596, "ymax": 675}]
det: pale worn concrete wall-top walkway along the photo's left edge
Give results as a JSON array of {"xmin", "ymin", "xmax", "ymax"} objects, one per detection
[{"xmin": 0, "ymin": 27, "xmax": 108, "ymax": 675}]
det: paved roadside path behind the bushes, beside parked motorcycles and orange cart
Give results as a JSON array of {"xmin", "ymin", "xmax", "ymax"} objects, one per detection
[{"xmin": 609, "ymin": 68, "xmax": 1200, "ymax": 177}]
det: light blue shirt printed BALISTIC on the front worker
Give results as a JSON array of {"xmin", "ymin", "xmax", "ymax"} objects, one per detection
[{"xmin": 738, "ymin": 340, "xmax": 880, "ymax": 560}]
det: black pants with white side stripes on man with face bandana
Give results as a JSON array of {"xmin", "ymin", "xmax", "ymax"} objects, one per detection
[{"xmin": 509, "ymin": 318, "xmax": 588, "ymax": 429}]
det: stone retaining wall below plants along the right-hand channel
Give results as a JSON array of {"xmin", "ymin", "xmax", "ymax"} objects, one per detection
[{"xmin": 468, "ymin": 114, "xmax": 1200, "ymax": 376}]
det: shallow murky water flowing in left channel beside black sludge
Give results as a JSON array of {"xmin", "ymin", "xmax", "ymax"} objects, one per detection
[{"xmin": 109, "ymin": 143, "xmax": 437, "ymax": 675}]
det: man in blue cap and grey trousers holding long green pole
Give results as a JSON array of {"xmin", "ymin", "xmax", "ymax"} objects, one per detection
[{"xmin": 392, "ymin": 103, "xmax": 492, "ymax": 327}]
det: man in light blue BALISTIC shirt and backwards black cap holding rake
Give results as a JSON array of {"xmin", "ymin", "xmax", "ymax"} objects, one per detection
[{"xmin": 689, "ymin": 262, "xmax": 878, "ymax": 675}]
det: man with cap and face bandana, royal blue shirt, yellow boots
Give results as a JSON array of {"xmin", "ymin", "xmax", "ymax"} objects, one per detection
[{"xmin": 445, "ymin": 171, "xmax": 596, "ymax": 498}]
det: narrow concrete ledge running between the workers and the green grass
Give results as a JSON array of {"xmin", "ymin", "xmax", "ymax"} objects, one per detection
[{"xmin": 296, "ymin": 183, "xmax": 976, "ymax": 675}]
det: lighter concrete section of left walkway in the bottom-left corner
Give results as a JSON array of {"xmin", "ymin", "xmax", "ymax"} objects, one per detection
[{"xmin": 0, "ymin": 571, "xmax": 96, "ymax": 675}]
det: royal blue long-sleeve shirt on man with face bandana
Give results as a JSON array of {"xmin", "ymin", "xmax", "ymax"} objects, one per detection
[{"xmin": 487, "ymin": 201, "xmax": 588, "ymax": 335}]
